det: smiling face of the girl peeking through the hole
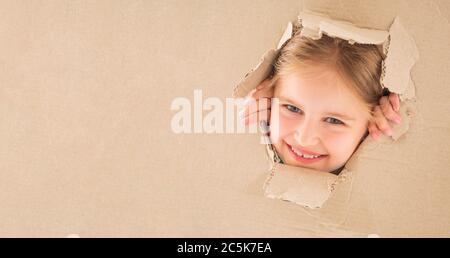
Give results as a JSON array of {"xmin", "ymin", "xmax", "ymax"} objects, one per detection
[{"xmin": 270, "ymin": 66, "xmax": 369, "ymax": 172}]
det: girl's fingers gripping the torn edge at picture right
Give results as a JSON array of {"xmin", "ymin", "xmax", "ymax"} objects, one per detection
[{"xmin": 369, "ymin": 93, "xmax": 402, "ymax": 140}]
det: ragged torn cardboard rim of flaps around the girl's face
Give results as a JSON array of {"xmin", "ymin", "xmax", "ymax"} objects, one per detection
[{"xmin": 233, "ymin": 12, "xmax": 419, "ymax": 212}]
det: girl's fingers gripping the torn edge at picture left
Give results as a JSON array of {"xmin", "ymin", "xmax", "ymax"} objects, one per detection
[{"xmin": 239, "ymin": 79, "xmax": 274, "ymax": 126}]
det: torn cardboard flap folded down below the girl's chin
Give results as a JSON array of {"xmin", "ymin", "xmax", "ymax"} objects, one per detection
[{"xmin": 264, "ymin": 163, "xmax": 338, "ymax": 209}]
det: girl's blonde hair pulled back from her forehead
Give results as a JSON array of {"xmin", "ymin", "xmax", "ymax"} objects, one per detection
[{"xmin": 272, "ymin": 30, "xmax": 383, "ymax": 120}]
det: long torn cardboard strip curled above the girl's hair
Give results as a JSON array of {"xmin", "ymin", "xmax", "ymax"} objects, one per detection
[{"xmin": 298, "ymin": 12, "xmax": 389, "ymax": 45}]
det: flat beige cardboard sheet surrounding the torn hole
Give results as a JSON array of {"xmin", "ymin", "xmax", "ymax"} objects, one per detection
[{"xmin": 0, "ymin": 0, "xmax": 450, "ymax": 237}]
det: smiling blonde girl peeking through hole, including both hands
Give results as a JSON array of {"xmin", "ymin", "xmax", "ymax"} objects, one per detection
[{"xmin": 241, "ymin": 31, "xmax": 401, "ymax": 173}]
